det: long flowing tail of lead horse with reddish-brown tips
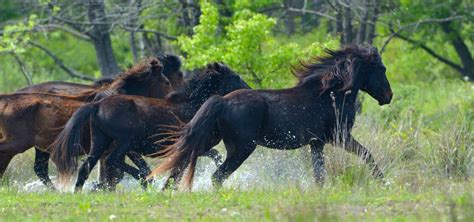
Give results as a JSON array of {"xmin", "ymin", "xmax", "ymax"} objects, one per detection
[{"xmin": 150, "ymin": 95, "xmax": 226, "ymax": 188}]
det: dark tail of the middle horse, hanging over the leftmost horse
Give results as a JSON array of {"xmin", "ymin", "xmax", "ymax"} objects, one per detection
[{"xmin": 51, "ymin": 103, "xmax": 98, "ymax": 186}]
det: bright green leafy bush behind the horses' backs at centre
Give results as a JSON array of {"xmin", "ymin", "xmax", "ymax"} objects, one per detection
[{"xmin": 178, "ymin": 1, "xmax": 337, "ymax": 88}]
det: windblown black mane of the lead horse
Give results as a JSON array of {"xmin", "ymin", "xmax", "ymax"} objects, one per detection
[{"xmin": 292, "ymin": 45, "xmax": 379, "ymax": 93}]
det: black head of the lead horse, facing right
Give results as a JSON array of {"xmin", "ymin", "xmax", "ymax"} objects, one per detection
[{"xmin": 360, "ymin": 46, "xmax": 393, "ymax": 105}]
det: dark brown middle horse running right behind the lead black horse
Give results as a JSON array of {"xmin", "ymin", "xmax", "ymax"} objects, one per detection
[{"xmin": 52, "ymin": 63, "xmax": 249, "ymax": 192}]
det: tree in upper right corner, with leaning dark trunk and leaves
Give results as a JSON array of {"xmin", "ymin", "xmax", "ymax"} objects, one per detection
[{"xmin": 383, "ymin": 0, "xmax": 474, "ymax": 81}]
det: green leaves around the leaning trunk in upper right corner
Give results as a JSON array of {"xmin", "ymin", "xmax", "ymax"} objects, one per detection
[{"xmin": 384, "ymin": 0, "xmax": 474, "ymax": 78}]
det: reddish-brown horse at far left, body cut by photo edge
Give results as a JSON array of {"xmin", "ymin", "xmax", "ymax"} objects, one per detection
[{"xmin": 0, "ymin": 58, "xmax": 171, "ymax": 188}]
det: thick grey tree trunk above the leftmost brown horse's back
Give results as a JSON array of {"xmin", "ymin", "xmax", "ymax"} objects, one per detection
[{"xmin": 87, "ymin": 0, "xmax": 120, "ymax": 76}]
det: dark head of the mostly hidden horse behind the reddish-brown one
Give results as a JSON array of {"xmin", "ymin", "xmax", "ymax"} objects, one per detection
[{"xmin": 156, "ymin": 54, "xmax": 185, "ymax": 89}]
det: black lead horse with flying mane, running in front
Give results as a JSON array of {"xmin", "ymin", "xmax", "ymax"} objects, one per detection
[{"xmin": 153, "ymin": 46, "xmax": 392, "ymax": 187}]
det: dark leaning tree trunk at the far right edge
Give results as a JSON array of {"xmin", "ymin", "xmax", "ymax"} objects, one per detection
[{"xmin": 440, "ymin": 22, "xmax": 474, "ymax": 81}]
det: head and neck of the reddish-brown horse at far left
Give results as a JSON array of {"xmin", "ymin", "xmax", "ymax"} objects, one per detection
[{"xmin": 112, "ymin": 58, "xmax": 172, "ymax": 98}]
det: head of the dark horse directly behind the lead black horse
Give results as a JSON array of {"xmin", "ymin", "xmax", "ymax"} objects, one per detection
[{"xmin": 205, "ymin": 62, "xmax": 250, "ymax": 95}]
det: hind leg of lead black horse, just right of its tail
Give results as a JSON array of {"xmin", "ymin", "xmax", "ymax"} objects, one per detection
[{"xmin": 212, "ymin": 139, "xmax": 257, "ymax": 188}]
